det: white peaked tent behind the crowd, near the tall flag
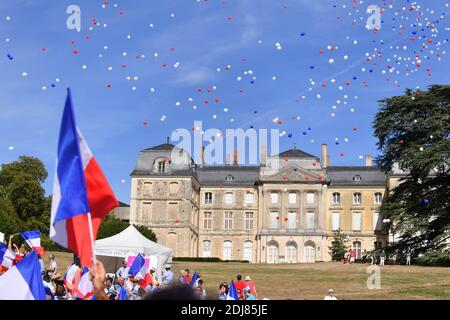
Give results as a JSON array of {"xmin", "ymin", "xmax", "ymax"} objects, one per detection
[{"xmin": 95, "ymin": 226, "xmax": 172, "ymax": 276}]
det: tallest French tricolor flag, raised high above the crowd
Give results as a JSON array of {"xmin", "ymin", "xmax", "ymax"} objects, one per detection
[{"xmin": 50, "ymin": 89, "xmax": 119, "ymax": 267}]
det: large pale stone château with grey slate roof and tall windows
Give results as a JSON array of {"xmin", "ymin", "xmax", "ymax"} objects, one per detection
[{"xmin": 130, "ymin": 143, "xmax": 389, "ymax": 263}]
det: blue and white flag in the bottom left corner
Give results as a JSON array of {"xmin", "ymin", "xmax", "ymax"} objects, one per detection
[{"xmin": 0, "ymin": 251, "xmax": 45, "ymax": 300}]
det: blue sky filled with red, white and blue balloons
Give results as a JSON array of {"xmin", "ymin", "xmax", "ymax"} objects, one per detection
[{"xmin": 0, "ymin": 0, "xmax": 450, "ymax": 202}]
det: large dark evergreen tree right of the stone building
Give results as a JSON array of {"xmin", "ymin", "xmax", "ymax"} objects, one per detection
[{"xmin": 374, "ymin": 85, "xmax": 450, "ymax": 255}]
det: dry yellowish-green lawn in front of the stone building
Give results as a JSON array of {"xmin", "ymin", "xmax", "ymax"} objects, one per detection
[{"xmin": 49, "ymin": 252, "xmax": 450, "ymax": 300}]
